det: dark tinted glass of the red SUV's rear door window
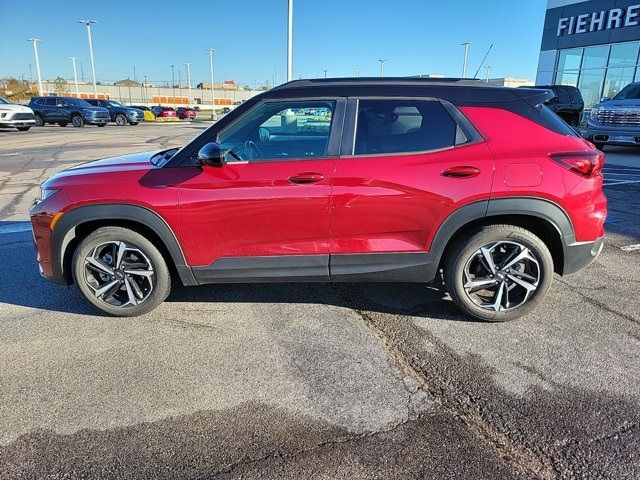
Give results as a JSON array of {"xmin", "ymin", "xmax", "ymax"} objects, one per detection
[{"xmin": 354, "ymin": 99, "xmax": 465, "ymax": 155}]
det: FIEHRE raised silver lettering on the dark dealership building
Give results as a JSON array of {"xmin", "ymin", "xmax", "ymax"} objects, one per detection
[{"xmin": 557, "ymin": 3, "xmax": 640, "ymax": 37}]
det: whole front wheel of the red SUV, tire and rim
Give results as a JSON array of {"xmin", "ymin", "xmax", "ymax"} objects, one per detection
[{"xmin": 73, "ymin": 227, "xmax": 171, "ymax": 317}]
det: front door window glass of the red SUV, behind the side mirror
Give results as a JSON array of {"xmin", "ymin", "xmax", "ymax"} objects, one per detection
[{"xmin": 218, "ymin": 100, "xmax": 336, "ymax": 162}]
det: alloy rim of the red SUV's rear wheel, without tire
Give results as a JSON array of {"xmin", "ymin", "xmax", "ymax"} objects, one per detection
[{"xmin": 463, "ymin": 241, "xmax": 541, "ymax": 312}]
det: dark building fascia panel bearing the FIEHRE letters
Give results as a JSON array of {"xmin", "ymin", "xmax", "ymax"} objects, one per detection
[{"xmin": 541, "ymin": 0, "xmax": 640, "ymax": 51}]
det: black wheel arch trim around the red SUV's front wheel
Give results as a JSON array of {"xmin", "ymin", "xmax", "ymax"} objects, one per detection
[{"xmin": 51, "ymin": 204, "xmax": 198, "ymax": 285}]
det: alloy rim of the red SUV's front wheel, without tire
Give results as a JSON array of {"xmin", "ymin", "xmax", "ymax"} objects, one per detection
[{"xmin": 84, "ymin": 241, "xmax": 155, "ymax": 308}]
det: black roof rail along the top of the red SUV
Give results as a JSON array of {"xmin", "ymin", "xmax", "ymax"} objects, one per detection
[{"xmin": 272, "ymin": 76, "xmax": 498, "ymax": 90}]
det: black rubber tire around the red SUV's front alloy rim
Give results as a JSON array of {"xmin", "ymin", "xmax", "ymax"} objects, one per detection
[{"xmin": 72, "ymin": 227, "xmax": 171, "ymax": 317}]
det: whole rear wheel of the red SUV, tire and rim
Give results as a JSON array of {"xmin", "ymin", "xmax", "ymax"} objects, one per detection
[{"xmin": 444, "ymin": 225, "xmax": 553, "ymax": 322}]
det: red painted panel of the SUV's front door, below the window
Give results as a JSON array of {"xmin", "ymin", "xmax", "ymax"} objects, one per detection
[{"xmin": 179, "ymin": 158, "xmax": 336, "ymax": 266}]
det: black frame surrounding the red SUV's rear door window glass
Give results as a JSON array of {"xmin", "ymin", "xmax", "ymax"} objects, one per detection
[{"xmin": 340, "ymin": 95, "xmax": 484, "ymax": 158}]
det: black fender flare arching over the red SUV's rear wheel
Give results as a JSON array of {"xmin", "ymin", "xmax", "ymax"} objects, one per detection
[{"xmin": 430, "ymin": 197, "xmax": 575, "ymax": 270}]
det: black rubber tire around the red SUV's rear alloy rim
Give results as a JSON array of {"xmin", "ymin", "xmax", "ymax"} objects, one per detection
[{"xmin": 444, "ymin": 225, "xmax": 553, "ymax": 322}]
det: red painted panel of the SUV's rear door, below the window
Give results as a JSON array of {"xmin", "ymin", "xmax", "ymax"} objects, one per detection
[{"xmin": 330, "ymin": 143, "xmax": 494, "ymax": 254}]
